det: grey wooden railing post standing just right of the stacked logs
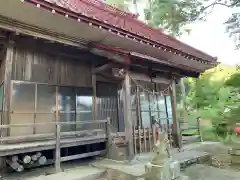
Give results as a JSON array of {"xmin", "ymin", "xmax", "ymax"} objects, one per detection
[{"xmin": 55, "ymin": 122, "xmax": 62, "ymax": 173}]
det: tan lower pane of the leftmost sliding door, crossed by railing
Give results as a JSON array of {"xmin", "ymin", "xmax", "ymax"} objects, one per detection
[{"xmin": 9, "ymin": 113, "xmax": 34, "ymax": 136}]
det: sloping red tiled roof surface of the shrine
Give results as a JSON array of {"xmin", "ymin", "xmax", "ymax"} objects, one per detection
[{"xmin": 26, "ymin": 0, "xmax": 217, "ymax": 63}]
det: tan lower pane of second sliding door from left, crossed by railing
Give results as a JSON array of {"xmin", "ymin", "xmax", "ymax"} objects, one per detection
[{"xmin": 35, "ymin": 114, "xmax": 56, "ymax": 134}]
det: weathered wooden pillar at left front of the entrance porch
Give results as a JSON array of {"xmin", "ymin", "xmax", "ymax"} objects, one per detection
[{"xmin": 123, "ymin": 72, "xmax": 134, "ymax": 161}]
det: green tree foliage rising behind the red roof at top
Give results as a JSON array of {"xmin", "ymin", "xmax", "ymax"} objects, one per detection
[{"xmin": 145, "ymin": 0, "xmax": 204, "ymax": 36}]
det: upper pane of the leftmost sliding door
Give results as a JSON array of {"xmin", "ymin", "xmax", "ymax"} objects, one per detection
[{"xmin": 12, "ymin": 83, "xmax": 35, "ymax": 112}]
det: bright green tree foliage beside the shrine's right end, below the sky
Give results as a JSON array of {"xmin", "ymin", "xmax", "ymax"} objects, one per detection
[{"xmin": 181, "ymin": 65, "xmax": 240, "ymax": 136}]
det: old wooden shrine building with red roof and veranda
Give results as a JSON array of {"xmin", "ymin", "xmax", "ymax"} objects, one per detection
[{"xmin": 0, "ymin": 0, "xmax": 217, "ymax": 171}]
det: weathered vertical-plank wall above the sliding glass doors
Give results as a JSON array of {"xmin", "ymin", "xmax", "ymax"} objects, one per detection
[{"xmin": 12, "ymin": 46, "xmax": 91, "ymax": 87}]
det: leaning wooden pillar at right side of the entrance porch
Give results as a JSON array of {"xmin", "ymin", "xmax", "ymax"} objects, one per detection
[{"xmin": 170, "ymin": 80, "xmax": 182, "ymax": 148}]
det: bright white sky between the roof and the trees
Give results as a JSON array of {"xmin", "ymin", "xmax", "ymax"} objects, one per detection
[{"xmin": 131, "ymin": 0, "xmax": 240, "ymax": 65}]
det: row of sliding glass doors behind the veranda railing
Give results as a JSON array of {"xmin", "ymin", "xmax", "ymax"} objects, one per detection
[{"xmin": 9, "ymin": 81, "xmax": 93, "ymax": 136}]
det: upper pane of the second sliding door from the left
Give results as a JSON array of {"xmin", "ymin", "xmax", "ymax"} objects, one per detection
[{"xmin": 36, "ymin": 85, "xmax": 56, "ymax": 113}]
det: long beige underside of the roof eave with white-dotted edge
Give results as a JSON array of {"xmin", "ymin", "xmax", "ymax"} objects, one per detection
[{"xmin": 0, "ymin": 0, "xmax": 217, "ymax": 75}]
